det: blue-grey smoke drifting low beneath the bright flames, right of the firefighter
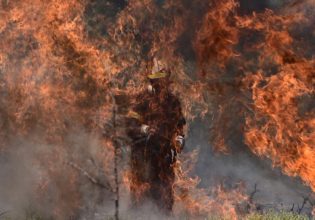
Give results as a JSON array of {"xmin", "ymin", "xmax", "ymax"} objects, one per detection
[{"xmin": 185, "ymin": 117, "xmax": 312, "ymax": 213}]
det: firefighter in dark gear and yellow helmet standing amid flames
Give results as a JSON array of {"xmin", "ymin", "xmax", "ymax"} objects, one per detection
[{"xmin": 127, "ymin": 60, "xmax": 186, "ymax": 212}]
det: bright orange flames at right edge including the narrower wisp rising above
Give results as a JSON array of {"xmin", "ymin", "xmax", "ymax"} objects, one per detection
[{"xmin": 240, "ymin": 3, "xmax": 315, "ymax": 191}]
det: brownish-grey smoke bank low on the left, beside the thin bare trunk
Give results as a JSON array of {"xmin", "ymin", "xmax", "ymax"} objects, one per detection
[{"xmin": 0, "ymin": 129, "xmax": 122, "ymax": 219}]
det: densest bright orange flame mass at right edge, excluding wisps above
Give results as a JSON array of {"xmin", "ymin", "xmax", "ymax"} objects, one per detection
[{"xmin": 245, "ymin": 62, "xmax": 315, "ymax": 190}]
